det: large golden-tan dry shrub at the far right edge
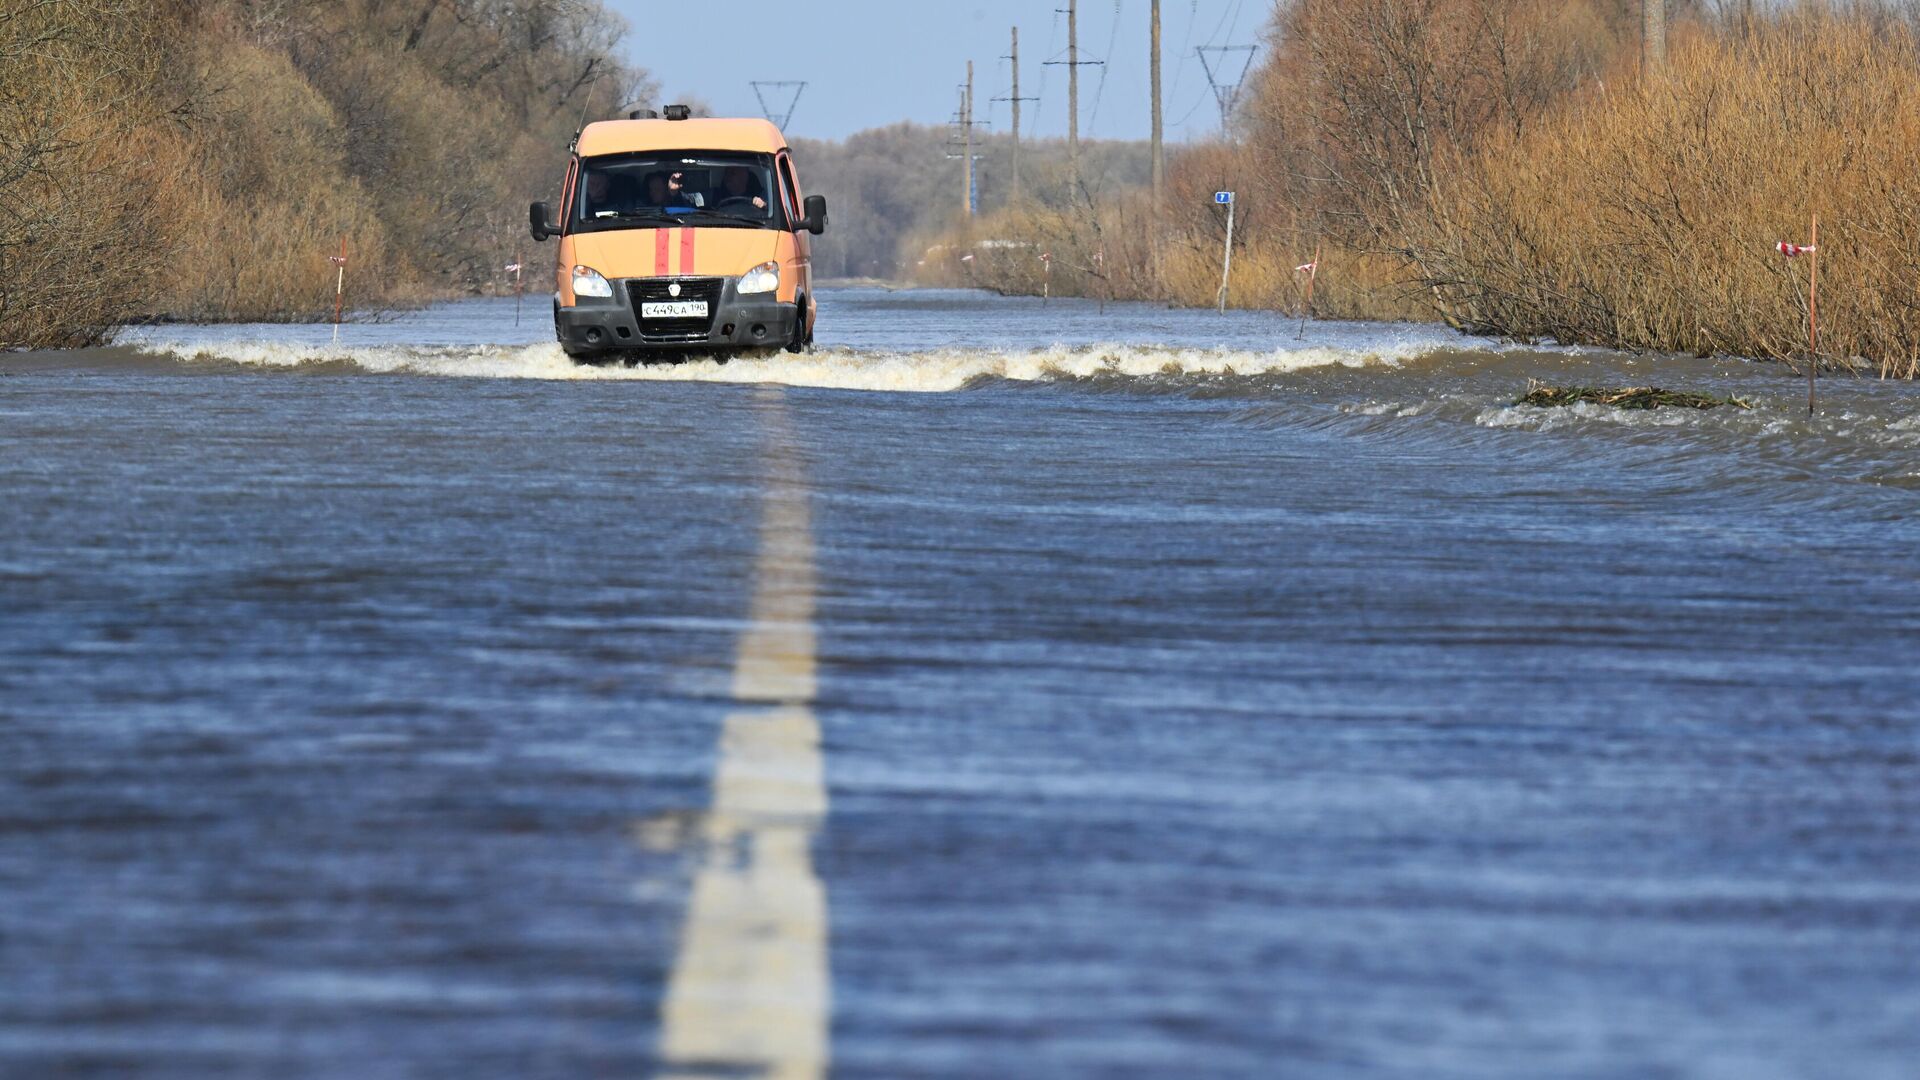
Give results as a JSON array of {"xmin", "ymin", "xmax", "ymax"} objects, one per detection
[{"xmin": 1413, "ymin": 12, "xmax": 1920, "ymax": 377}]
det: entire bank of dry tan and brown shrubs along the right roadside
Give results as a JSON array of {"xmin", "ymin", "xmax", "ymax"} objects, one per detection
[{"xmin": 922, "ymin": 0, "xmax": 1920, "ymax": 377}]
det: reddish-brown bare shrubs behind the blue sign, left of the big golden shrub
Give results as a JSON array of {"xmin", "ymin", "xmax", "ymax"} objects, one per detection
[{"xmin": 924, "ymin": 0, "xmax": 1632, "ymax": 319}]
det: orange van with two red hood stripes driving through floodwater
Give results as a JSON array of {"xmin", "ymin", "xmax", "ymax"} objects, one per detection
[{"xmin": 528, "ymin": 106, "xmax": 828, "ymax": 361}]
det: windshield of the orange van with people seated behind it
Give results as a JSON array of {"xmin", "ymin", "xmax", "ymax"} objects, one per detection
[{"xmin": 570, "ymin": 152, "xmax": 787, "ymax": 233}]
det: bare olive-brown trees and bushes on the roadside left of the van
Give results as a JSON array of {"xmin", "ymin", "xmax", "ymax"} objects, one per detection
[{"xmin": 0, "ymin": 0, "xmax": 651, "ymax": 348}]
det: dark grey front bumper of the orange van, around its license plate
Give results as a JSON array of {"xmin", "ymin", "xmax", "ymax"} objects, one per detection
[{"xmin": 553, "ymin": 277, "xmax": 801, "ymax": 356}]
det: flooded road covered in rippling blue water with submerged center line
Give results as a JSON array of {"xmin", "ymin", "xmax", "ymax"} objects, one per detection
[{"xmin": 0, "ymin": 290, "xmax": 1920, "ymax": 1080}]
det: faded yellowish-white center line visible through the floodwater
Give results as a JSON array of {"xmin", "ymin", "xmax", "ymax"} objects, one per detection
[{"xmin": 660, "ymin": 390, "xmax": 831, "ymax": 1080}]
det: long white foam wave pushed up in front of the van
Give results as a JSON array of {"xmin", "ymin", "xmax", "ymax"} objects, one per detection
[{"xmin": 140, "ymin": 342, "xmax": 1444, "ymax": 392}]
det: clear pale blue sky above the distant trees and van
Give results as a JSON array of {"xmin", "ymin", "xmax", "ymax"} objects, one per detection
[{"xmin": 605, "ymin": 0, "xmax": 1271, "ymax": 142}]
